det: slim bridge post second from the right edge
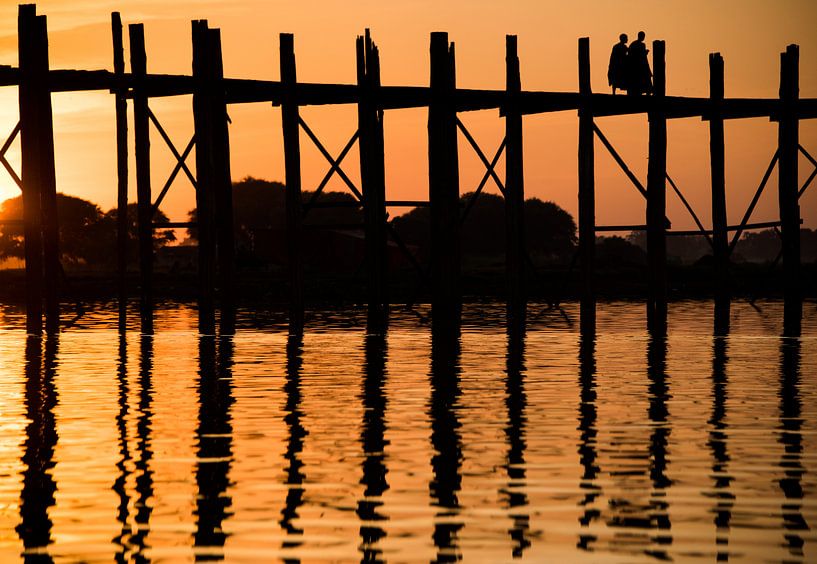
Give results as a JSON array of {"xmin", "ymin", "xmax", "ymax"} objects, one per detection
[{"xmin": 709, "ymin": 53, "xmax": 730, "ymax": 335}]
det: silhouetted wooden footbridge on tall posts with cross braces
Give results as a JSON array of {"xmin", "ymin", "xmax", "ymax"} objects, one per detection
[{"xmin": 0, "ymin": 5, "xmax": 817, "ymax": 333}]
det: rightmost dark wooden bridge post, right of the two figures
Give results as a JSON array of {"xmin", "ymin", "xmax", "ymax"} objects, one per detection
[{"xmin": 777, "ymin": 45, "xmax": 802, "ymax": 334}]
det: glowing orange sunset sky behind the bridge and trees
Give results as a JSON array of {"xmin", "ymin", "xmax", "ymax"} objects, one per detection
[{"xmin": 0, "ymin": 0, "xmax": 817, "ymax": 234}]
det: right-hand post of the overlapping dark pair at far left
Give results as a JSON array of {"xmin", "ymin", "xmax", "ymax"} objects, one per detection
[{"xmin": 35, "ymin": 16, "xmax": 62, "ymax": 333}]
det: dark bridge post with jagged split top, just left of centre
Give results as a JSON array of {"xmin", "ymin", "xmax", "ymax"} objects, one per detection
[{"xmin": 357, "ymin": 29, "xmax": 388, "ymax": 329}]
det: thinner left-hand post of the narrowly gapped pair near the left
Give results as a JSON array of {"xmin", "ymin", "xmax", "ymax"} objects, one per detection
[{"xmin": 111, "ymin": 12, "xmax": 128, "ymax": 330}]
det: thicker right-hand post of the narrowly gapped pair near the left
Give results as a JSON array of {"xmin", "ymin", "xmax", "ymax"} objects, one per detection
[{"xmin": 128, "ymin": 24, "xmax": 153, "ymax": 333}]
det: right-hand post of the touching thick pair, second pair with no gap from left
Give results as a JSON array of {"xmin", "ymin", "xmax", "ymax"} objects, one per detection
[{"xmin": 207, "ymin": 29, "xmax": 235, "ymax": 335}]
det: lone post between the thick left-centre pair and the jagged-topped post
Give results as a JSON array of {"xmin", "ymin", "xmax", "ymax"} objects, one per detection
[{"xmin": 280, "ymin": 33, "xmax": 304, "ymax": 329}]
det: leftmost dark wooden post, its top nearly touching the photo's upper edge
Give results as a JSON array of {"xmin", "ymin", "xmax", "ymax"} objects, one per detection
[{"xmin": 17, "ymin": 4, "xmax": 45, "ymax": 334}]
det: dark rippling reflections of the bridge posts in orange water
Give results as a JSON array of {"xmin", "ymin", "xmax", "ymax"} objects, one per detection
[{"xmin": 12, "ymin": 306, "xmax": 812, "ymax": 562}]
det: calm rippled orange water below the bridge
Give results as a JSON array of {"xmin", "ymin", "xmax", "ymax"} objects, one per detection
[{"xmin": 0, "ymin": 301, "xmax": 817, "ymax": 562}]
